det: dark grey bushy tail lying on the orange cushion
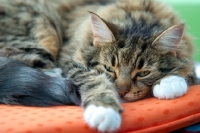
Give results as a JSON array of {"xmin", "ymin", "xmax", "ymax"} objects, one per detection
[{"xmin": 0, "ymin": 57, "xmax": 80, "ymax": 106}]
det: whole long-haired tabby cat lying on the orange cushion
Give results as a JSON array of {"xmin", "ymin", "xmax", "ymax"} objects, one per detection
[{"xmin": 0, "ymin": 0, "xmax": 196, "ymax": 132}]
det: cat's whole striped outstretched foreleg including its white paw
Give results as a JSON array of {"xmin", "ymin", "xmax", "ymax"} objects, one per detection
[{"xmin": 63, "ymin": 61, "xmax": 122, "ymax": 132}]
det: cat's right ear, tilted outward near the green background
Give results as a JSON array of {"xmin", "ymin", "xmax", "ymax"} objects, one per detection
[{"xmin": 152, "ymin": 24, "xmax": 184, "ymax": 55}]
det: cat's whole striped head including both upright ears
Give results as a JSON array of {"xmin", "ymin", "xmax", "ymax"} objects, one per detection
[{"xmin": 88, "ymin": 13, "xmax": 184, "ymax": 101}]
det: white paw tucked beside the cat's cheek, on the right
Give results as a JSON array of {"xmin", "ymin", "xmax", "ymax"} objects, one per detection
[{"xmin": 153, "ymin": 76, "xmax": 188, "ymax": 99}]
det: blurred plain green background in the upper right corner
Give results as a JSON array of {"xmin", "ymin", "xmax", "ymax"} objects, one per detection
[{"xmin": 160, "ymin": 0, "xmax": 200, "ymax": 62}]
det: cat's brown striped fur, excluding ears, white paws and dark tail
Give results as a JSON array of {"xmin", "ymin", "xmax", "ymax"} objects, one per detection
[{"xmin": 0, "ymin": 0, "xmax": 195, "ymax": 112}]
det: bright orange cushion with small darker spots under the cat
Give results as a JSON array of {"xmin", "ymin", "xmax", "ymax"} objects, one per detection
[{"xmin": 0, "ymin": 85, "xmax": 200, "ymax": 133}]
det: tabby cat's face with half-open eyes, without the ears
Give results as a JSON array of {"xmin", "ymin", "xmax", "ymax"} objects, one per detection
[{"xmin": 98, "ymin": 42, "xmax": 173, "ymax": 101}]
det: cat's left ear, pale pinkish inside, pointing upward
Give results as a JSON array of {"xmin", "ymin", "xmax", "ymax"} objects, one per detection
[{"xmin": 90, "ymin": 12, "xmax": 115, "ymax": 46}]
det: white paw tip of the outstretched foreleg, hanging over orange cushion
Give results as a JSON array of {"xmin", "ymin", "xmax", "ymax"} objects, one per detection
[{"xmin": 84, "ymin": 105, "xmax": 121, "ymax": 132}]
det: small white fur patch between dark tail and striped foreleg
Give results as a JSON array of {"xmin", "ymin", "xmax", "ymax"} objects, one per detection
[{"xmin": 43, "ymin": 68, "xmax": 62, "ymax": 78}]
